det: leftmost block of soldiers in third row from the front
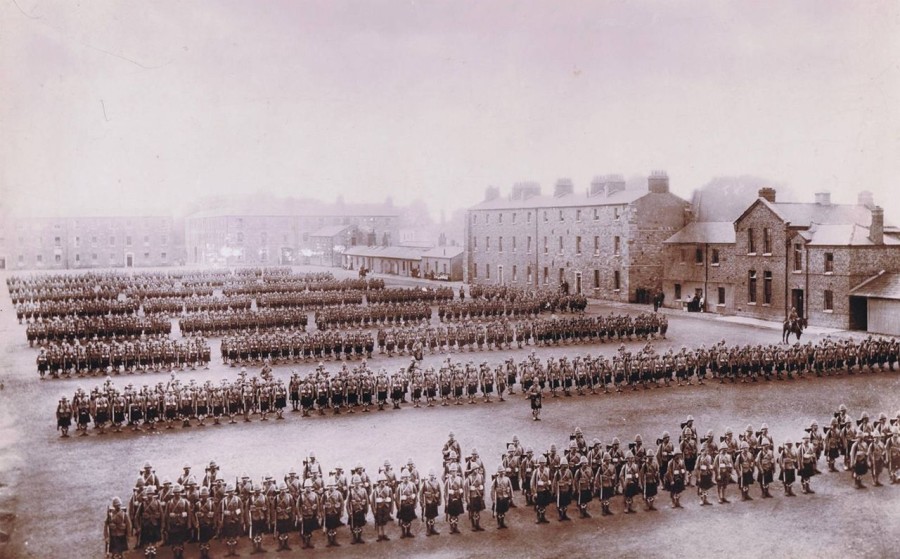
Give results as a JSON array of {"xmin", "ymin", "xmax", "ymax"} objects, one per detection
[{"xmin": 36, "ymin": 334, "xmax": 210, "ymax": 378}]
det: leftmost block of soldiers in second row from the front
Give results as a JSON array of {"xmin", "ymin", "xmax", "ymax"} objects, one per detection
[{"xmin": 56, "ymin": 368, "xmax": 288, "ymax": 437}]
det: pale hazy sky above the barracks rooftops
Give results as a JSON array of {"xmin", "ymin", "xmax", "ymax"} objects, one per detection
[{"xmin": 0, "ymin": 0, "xmax": 900, "ymax": 223}]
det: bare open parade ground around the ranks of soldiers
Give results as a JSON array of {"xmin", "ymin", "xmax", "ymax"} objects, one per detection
[{"xmin": 0, "ymin": 276, "xmax": 900, "ymax": 559}]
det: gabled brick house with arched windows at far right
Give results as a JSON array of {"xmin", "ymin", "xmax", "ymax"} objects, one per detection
[{"xmin": 663, "ymin": 188, "xmax": 900, "ymax": 329}]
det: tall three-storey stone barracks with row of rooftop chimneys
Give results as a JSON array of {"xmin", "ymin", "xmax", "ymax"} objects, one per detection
[{"xmin": 466, "ymin": 172, "xmax": 689, "ymax": 301}]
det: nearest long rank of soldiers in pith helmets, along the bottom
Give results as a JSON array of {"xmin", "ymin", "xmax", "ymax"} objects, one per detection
[{"xmin": 104, "ymin": 405, "xmax": 900, "ymax": 557}]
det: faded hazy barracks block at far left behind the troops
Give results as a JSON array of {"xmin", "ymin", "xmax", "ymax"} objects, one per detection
[{"xmin": 0, "ymin": 216, "xmax": 184, "ymax": 270}]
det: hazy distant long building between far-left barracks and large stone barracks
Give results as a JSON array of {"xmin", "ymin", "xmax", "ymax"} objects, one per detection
[{"xmin": 185, "ymin": 200, "xmax": 399, "ymax": 266}]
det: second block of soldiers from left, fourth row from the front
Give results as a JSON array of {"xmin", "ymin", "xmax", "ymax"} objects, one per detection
[{"xmin": 178, "ymin": 308, "xmax": 309, "ymax": 336}]
